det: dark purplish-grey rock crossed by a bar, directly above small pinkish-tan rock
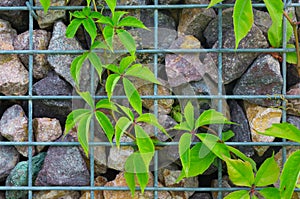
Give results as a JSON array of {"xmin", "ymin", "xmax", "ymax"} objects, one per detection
[{"xmin": 33, "ymin": 73, "xmax": 72, "ymax": 124}]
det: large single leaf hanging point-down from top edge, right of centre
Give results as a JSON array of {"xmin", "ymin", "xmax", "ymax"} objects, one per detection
[{"xmin": 233, "ymin": 0, "xmax": 254, "ymax": 49}]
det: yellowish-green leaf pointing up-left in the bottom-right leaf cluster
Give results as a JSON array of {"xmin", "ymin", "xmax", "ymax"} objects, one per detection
[{"xmin": 224, "ymin": 157, "xmax": 254, "ymax": 187}]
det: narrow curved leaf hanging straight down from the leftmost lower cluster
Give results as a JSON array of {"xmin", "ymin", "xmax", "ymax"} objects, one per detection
[{"xmin": 77, "ymin": 114, "xmax": 93, "ymax": 156}]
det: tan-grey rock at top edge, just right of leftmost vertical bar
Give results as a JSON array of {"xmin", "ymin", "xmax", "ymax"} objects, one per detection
[{"xmin": 34, "ymin": 0, "xmax": 66, "ymax": 29}]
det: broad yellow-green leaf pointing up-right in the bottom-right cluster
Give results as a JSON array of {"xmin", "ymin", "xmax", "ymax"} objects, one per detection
[{"xmin": 254, "ymin": 154, "xmax": 280, "ymax": 186}]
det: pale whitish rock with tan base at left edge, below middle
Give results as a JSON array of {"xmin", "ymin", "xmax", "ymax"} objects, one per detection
[{"xmin": 0, "ymin": 104, "xmax": 34, "ymax": 157}]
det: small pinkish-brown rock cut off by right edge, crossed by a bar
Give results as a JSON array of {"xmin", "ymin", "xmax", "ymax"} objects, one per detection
[{"xmin": 286, "ymin": 83, "xmax": 300, "ymax": 116}]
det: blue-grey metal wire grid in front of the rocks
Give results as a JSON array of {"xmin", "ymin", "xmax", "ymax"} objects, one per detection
[{"xmin": 0, "ymin": 0, "xmax": 300, "ymax": 199}]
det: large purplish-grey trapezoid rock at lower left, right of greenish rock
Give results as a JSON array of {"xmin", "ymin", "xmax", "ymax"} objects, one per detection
[{"xmin": 35, "ymin": 136, "xmax": 90, "ymax": 186}]
